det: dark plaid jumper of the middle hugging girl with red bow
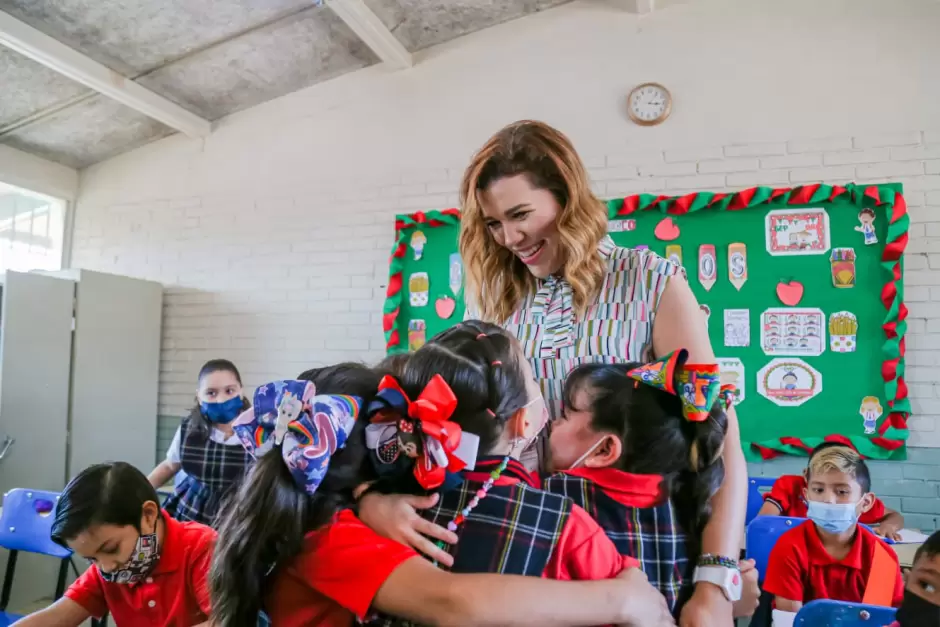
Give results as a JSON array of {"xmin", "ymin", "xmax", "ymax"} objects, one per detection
[{"xmin": 368, "ymin": 456, "xmax": 572, "ymax": 627}]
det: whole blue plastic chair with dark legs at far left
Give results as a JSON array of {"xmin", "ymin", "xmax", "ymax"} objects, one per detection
[{"xmin": 0, "ymin": 488, "xmax": 72, "ymax": 627}]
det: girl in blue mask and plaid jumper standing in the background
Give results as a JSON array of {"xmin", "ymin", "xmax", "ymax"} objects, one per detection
[{"xmin": 147, "ymin": 359, "xmax": 251, "ymax": 526}]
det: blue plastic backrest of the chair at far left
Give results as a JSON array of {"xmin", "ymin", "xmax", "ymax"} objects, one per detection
[{"xmin": 0, "ymin": 488, "xmax": 72, "ymax": 559}]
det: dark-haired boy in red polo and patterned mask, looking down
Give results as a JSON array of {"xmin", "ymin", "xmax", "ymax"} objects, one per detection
[{"xmin": 16, "ymin": 462, "xmax": 216, "ymax": 627}]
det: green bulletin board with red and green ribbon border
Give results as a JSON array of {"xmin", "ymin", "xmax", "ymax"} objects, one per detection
[{"xmin": 384, "ymin": 184, "xmax": 910, "ymax": 459}]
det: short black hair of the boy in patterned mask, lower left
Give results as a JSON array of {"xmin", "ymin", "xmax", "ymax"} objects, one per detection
[{"xmin": 51, "ymin": 462, "xmax": 160, "ymax": 548}]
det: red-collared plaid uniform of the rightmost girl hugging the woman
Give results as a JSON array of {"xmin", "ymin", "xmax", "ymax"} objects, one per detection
[{"xmin": 544, "ymin": 468, "xmax": 698, "ymax": 616}]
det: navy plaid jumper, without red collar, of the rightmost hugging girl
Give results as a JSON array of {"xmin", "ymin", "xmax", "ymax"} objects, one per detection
[{"xmin": 542, "ymin": 471, "xmax": 698, "ymax": 618}]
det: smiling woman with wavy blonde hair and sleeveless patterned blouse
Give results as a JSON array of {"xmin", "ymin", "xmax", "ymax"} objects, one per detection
[{"xmin": 459, "ymin": 121, "xmax": 747, "ymax": 627}]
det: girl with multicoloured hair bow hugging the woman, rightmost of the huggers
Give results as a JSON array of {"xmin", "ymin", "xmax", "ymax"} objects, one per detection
[{"xmin": 545, "ymin": 350, "xmax": 756, "ymax": 616}]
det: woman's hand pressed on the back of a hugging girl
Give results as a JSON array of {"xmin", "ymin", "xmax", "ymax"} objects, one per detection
[{"xmin": 359, "ymin": 492, "xmax": 457, "ymax": 566}]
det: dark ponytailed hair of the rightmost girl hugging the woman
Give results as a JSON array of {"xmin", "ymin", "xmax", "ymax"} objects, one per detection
[{"xmin": 563, "ymin": 363, "xmax": 728, "ymax": 537}]
